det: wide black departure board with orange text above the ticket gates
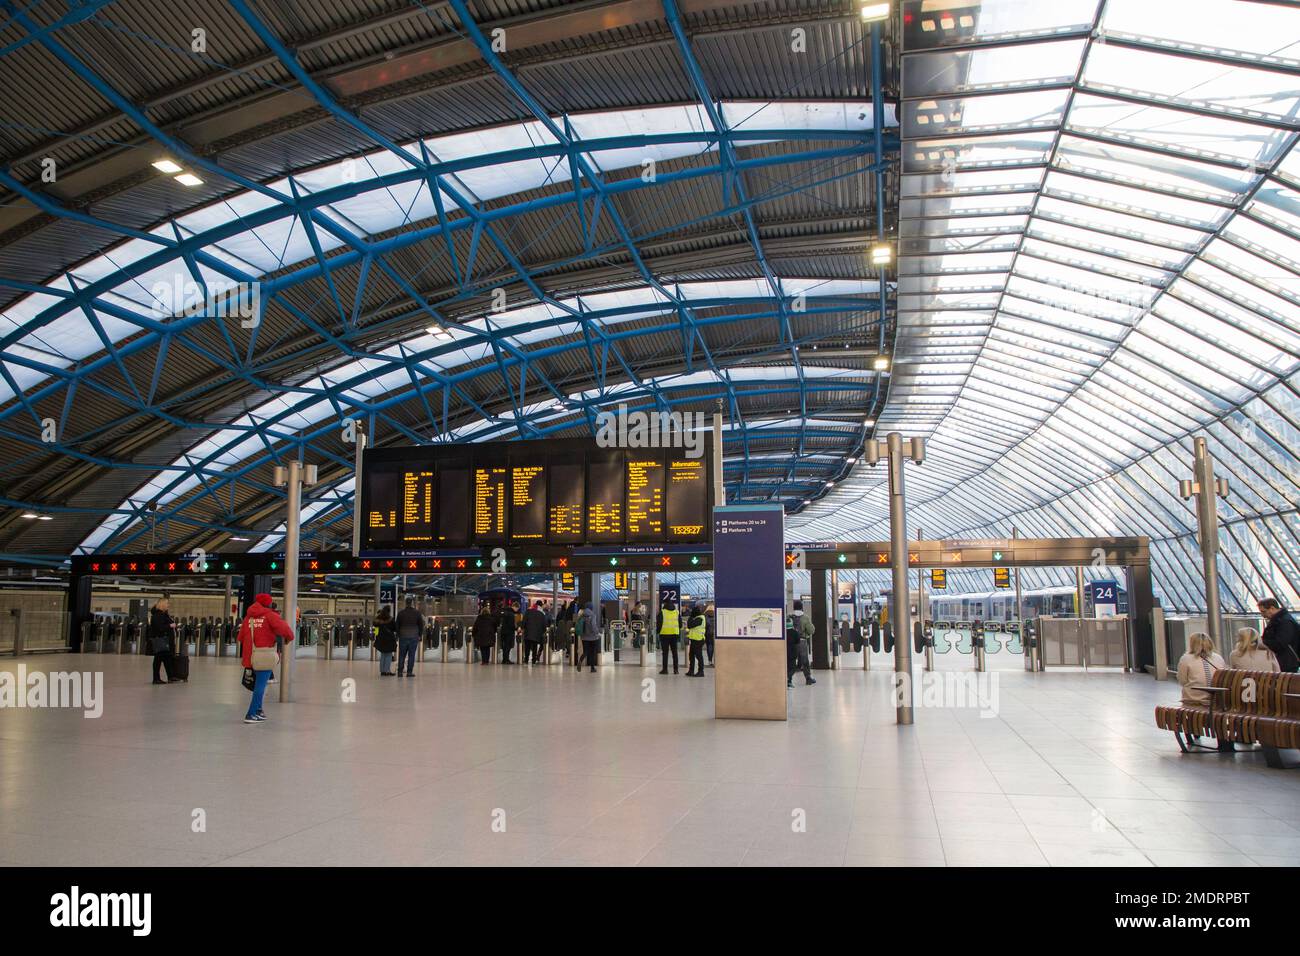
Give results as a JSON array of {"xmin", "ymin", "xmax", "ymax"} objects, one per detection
[{"xmin": 360, "ymin": 438, "xmax": 714, "ymax": 553}]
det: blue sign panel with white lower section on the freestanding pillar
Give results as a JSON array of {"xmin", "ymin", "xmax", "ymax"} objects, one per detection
[{"xmin": 714, "ymin": 505, "xmax": 785, "ymax": 640}]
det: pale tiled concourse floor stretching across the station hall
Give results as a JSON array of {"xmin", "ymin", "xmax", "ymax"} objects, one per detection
[{"xmin": 0, "ymin": 656, "xmax": 1300, "ymax": 866}]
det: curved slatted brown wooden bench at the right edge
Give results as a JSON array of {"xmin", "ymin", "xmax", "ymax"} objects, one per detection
[{"xmin": 1156, "ymin": 669, "xmax": 1300, "ymax": 767}]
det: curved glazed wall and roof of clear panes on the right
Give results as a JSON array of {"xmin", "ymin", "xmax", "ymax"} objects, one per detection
[{"xmin": 797, "ymin": 0, "xmax": 1300, "ymax": 610}]
